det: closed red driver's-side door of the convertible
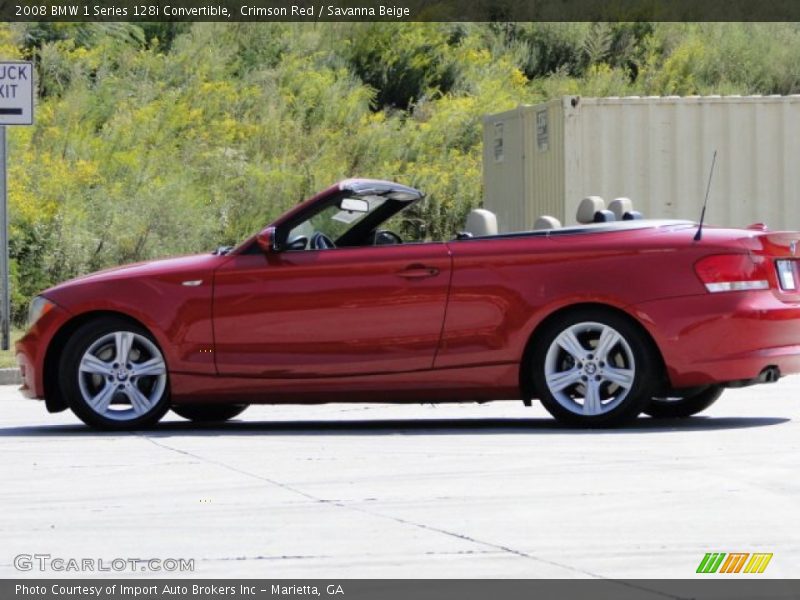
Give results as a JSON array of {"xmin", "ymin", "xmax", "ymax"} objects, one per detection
[{"xmin": 213, "ymin": 243, "xmax": 451, "ymax": 378}]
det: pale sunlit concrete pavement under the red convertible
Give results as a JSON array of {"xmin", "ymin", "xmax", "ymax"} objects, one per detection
[{"xmin": 0, "ymin": 377, "xmax": 800, "ymax": 578}]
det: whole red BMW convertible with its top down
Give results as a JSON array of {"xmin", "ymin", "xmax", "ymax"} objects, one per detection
[{"xmin": 16, "ymin": 179, "xmax": 800, "ymax": 429}]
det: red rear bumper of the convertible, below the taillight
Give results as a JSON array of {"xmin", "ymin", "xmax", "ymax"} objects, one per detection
[{"xmin": 631, "ymin": 290, "xmax": 800, "ymax": 388}]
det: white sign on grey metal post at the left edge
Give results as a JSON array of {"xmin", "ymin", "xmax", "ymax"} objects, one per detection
[{"xmin": 0, "ymin": 61, "xmax": 33, "ymax": 350}]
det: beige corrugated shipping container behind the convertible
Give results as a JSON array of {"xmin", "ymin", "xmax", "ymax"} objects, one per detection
[{"xmin": 483, "ymin": 95, "xmax": 800, "ymax": 231}]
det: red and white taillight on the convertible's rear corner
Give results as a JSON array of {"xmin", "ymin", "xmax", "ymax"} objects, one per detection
[{"xmin": 694, "ymin": 254, "xmax": 770, "ymax": 293}]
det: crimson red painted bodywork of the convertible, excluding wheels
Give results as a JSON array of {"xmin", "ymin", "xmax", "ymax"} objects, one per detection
[{"xmin": 17, "ymin": 182, "xmax": 800, "ymax": 420}]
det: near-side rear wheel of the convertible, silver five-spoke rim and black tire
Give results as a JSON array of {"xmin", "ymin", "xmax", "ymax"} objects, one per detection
[{"xmin": 526, "ymin": 308, "xmax": 663, "ymax": 427}]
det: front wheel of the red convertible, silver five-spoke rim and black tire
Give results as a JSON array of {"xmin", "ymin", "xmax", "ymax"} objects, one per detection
[{"xmin": 59, "ymin": 317, "xmax": 169, "ymax": 430}]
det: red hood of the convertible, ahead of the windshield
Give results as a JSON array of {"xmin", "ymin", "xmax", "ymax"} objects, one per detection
[{"xmin": 43, "ymin": 254, "xmax": 227, "ymax": 296}]
